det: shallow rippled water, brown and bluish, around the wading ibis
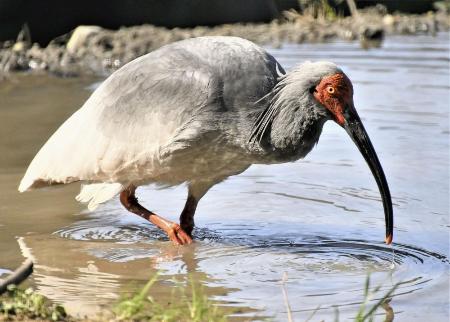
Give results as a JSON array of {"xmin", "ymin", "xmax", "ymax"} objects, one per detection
[{"xmin": 0, "ymin": 34, "xmax": 450, "ymax": 321}]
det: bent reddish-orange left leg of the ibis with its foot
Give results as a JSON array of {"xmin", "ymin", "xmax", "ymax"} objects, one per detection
[{"xmin": 120, "ymin": 186, "xmax": 192, "ymax": 245}]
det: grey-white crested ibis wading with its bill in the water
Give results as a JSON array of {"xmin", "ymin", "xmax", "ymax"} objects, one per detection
[{"xmin": 18, "ymin": 36, "xmax": 393, "ymax": 245}]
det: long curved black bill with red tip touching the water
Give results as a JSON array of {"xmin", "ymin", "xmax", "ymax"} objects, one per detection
[{"xmin": 343, "ymin": 104, "xmax": 394, "ymax": 245}]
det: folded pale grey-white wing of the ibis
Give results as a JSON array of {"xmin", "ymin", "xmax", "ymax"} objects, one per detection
[{"xmin": 19, "ymin": 48, "xmax": 220, "ymax": 191}]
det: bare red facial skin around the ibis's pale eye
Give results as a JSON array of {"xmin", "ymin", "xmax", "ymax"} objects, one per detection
[{"xmin": 314, "ymin": 73, "xmax": 353, "ymax": 126}]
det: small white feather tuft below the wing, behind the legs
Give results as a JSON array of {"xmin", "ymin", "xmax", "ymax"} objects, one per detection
[{"xmin": 75, "ymin": 183, "xmax": 124, "ymax": 211}]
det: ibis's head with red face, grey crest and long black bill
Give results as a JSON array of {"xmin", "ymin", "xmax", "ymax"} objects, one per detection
[{"xmin": 297, "ymin": 62, "xmax": 393, "ymax": 244}]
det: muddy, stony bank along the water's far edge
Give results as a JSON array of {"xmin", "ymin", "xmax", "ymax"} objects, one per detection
[{"xmin": 0, "ymin": 7, "xmax": 450, "ymax": 76}]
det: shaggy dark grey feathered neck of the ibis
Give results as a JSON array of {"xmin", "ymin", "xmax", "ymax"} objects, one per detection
[{"xmin": 251, "ymin": 82, "xmax": 327, "ymax": 161}]
